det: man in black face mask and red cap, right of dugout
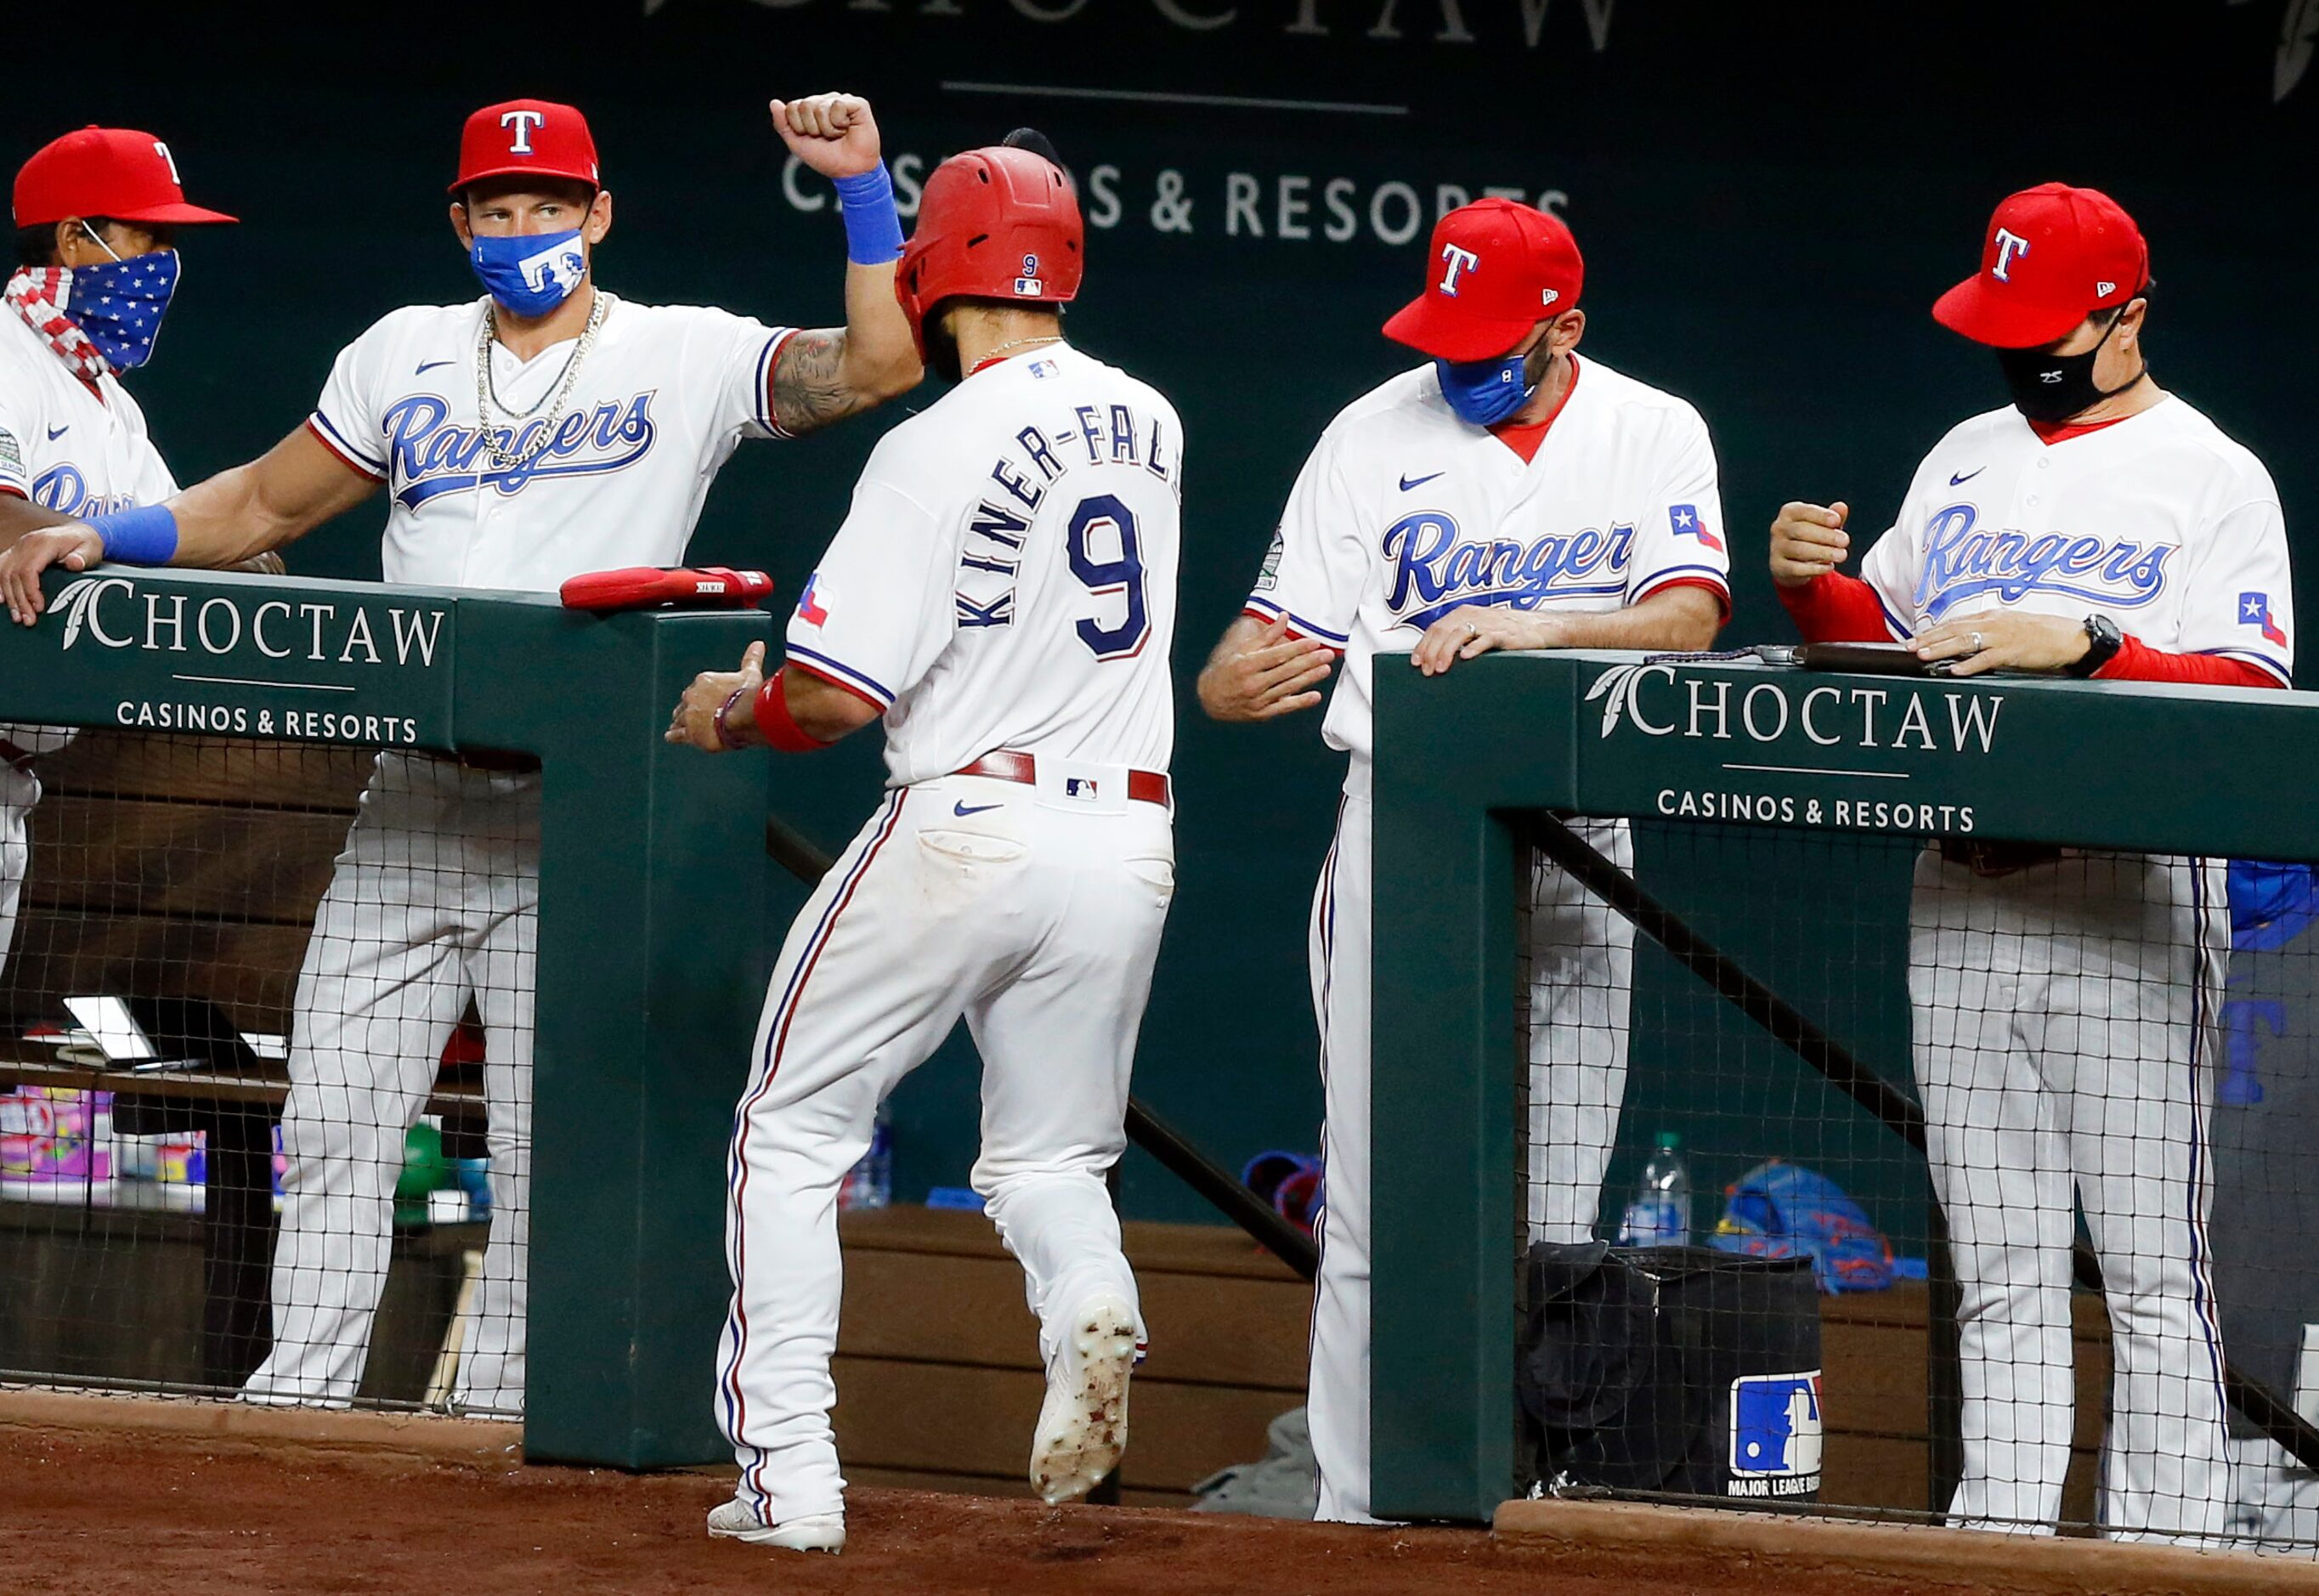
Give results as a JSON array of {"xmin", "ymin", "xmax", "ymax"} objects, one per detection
[{"xmin": 1772, "ymin": 184, "xmax": 2294, "ymax": 1538}]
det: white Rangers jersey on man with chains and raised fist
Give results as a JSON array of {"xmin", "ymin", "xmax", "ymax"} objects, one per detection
[{"xmin": 306, "ymin": 290, "xmax": 793, "ymax": 591}]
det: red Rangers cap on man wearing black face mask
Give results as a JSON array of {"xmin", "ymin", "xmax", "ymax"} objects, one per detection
[{"xmin": 1932, "ymin": 184, "xmax": 2150, "ymax": 348}]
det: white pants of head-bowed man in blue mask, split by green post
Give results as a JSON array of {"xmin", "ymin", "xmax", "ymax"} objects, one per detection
[{"xmin": 1308, "ymin": 779, "xmax": 1635, "ymax": 1524}]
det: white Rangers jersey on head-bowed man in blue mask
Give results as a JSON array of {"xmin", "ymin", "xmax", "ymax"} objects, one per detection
[{"xmin": 1247, "ymin": 359, "xmax": 1730, "ymax": 782}]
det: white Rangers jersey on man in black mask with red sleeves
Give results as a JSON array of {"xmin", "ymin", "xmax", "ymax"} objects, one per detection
[{"xmin": 1860, "ymin": 397, "xmax": 2296, "ymax": 687}]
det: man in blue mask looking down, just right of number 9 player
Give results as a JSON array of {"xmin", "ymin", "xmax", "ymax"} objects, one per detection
[{"xmin": 1199, "ymin": 200, "xmax": 1730, "ymax": 1522}]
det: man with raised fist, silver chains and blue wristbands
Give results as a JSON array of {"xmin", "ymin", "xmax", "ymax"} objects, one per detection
[{"xmin": 0, "ymin": 95, "xmax": 919, "ymax": 1412}]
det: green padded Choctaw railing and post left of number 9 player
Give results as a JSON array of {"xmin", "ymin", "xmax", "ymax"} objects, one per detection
[{"xmin": 0, "ymin": 566, "xmax": 770, "ymax": 1469}]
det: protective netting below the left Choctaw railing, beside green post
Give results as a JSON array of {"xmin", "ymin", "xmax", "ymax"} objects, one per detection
[{"xmin": 0, "ymin": 726, "xmax": 538, "ymax": 1412}]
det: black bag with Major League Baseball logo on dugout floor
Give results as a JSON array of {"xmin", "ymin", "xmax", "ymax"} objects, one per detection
[{"xmin": 1514, "ymin": 1241, "xmax": 1820, "ymax": 1501}]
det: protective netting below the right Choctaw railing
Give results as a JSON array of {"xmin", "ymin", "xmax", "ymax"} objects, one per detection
[{"xmin": 1514, "ymin": 817, "xmax": 2319, "ymax": 1552}]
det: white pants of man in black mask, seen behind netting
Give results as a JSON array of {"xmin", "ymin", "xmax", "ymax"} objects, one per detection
[{"xmin": 1909, "ymin": 849, "xmax": 2231, "ymax": 1542}]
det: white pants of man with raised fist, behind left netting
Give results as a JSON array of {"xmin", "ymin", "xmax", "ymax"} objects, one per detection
[{"xmin": 241, "ymin": 754, "xmax": 540, "ymax": 1415}]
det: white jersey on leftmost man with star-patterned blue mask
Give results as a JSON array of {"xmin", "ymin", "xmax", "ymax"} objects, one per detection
[{"xmin": 0, "ymin": 308, "xmax": 176, "ymax": 515}]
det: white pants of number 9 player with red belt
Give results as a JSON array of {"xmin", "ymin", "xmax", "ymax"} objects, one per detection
[{"xmin": 716, "ymin": 774, "xmax": 1176, "ymax": 1524}]
